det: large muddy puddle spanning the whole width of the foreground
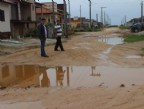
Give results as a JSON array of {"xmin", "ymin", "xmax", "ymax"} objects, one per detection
[{"xmin": 0, "ymin": 65, "xmax": 144, "ymax": 88}]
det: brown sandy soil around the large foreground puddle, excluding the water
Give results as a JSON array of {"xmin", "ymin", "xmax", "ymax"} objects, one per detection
[{"xmin": 0, "ymin": 28, "xmax": 144, "ymax": 109}]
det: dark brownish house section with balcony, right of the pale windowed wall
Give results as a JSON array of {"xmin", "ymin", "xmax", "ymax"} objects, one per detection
[{"xmin": 11, "ymin": 0, "xmax": 37, "ymax": 38}]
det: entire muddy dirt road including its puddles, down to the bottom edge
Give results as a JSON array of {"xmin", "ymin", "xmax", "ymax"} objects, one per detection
[{"xmin": 0, "ymin": 28, "xmax": 144, "ymax": 109}]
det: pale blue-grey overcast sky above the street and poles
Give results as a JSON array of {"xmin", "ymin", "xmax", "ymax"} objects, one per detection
[{"xmin": 37, "ymin": 0, "xmax": 141, "ymax": 25}]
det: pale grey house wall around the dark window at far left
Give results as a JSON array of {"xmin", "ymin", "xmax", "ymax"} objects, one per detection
[{"xmin": 0, "ymin": 2, "xmax": 11, "ymax": 32}]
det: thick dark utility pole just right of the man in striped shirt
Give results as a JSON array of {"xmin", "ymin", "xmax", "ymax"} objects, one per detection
[{"xmin": 63, "ymin": 0, "xmax": 68, "ymax": 38}]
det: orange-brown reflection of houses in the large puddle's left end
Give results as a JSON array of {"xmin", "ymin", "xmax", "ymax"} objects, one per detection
[{"xmin": 0, "ymin": 65, "xmax": 46, "ymax": 87}]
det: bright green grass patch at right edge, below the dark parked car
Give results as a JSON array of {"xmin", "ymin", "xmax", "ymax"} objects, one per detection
[{"xmin": 124, "ymin": 35, "xmax": 144, "ymax": 42}]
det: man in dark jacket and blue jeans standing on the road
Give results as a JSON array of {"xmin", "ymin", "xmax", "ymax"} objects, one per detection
[{"xmin": 38, "ymin": 18, "xmax": 48, "ymax": 57}]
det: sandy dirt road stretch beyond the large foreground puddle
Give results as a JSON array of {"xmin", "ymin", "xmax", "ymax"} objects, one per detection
[{"xmin": 0, "ymin": 28, "xmax": 144, "ymax": 67}]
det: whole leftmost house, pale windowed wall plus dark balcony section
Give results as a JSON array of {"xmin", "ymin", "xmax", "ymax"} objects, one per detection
[{"xmin": 0, "ymin": 0, "xmax": 42, "ymax": 38}]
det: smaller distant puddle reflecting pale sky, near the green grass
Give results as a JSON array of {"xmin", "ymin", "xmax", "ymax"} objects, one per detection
[{"xmin": 98, "ymin": 37, "xmax": 123, "ymax": 45}]
